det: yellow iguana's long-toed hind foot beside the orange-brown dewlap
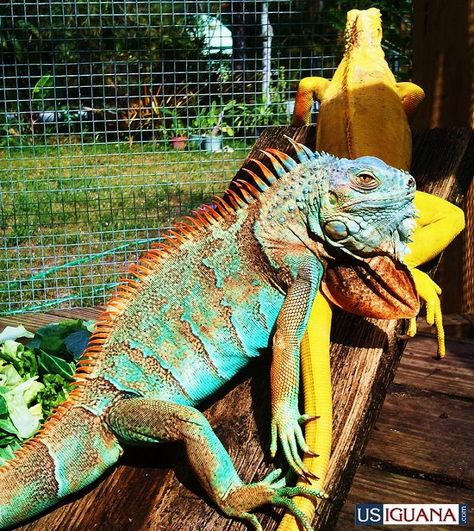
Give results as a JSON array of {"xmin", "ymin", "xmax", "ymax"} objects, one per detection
[{"xmin": 407, "ymin": 269, "xmax": 446, "ymax": 358}]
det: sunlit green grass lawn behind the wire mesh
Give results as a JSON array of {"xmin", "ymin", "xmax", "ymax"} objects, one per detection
[{"xmin": 0, "ymin": 144, "xmax": 250, "ymax": 313}]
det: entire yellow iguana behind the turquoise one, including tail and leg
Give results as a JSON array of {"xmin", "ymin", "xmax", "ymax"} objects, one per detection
[{"xmin": 279, "ymin": 8, "xmax": 464, "ymax": 531}]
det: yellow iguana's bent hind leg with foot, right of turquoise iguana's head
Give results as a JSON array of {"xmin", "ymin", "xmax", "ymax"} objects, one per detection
[{"xmin": 405, "ymin": 192, "xmax": 465, "ymax": 358}]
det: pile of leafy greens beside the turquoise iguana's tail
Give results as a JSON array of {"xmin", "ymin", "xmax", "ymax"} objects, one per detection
[{"xmin": 0, "ymin": 319, "xmax": 93, "ymax": 465}]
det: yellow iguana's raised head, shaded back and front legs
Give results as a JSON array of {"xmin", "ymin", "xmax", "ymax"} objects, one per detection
[{"xmin": 292, "ymin": 8, "xmax": 424, "ymax": 169}]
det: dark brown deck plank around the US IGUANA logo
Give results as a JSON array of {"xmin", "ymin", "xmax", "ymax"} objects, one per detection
[{"xmin": 335, "ymin": 465, "xmax": 474, "ymax": 531}]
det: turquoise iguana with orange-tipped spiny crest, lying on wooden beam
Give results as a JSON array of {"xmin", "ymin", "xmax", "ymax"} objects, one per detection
[{"xmin": 0, "ymin": 144, "xmax": 418, "ymax": 530}]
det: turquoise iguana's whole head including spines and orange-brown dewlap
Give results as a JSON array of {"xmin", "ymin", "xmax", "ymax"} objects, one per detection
[{"xmin": 250, "ymin": 140, "xmax": 418, "ymax": 319}]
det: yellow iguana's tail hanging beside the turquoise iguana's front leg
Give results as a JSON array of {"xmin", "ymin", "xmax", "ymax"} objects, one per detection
[{"xmin": 278, "ymin": 293, "xmax": 332, "ymax": 531}]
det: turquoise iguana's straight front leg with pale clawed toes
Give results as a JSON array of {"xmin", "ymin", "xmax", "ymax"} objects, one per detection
[{"xmin": 271, "ymin": 257, "xmax": 323, "ymax": 477}]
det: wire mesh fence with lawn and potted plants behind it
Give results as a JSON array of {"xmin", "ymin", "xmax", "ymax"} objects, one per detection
[{"xmin": 0, "ymin": 0, "xmax": 410, "ymax": 313}]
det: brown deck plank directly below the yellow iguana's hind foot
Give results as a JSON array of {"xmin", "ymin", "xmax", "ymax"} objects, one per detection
[{"xmin": 395, "ymin": 335, "xmax": 474, "ymax": 400}]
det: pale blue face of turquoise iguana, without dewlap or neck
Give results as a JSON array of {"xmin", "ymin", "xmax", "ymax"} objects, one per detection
[{"xmin": 309, "ymin": 157, "xmax": 416, "ymax": 260}]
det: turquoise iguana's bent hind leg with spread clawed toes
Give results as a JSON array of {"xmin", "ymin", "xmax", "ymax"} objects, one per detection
[{"xmin": 107, "ymin": 398, "xmax": 325, "ymax": 531}]
